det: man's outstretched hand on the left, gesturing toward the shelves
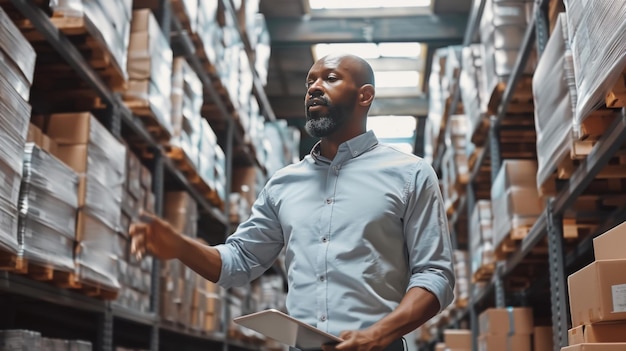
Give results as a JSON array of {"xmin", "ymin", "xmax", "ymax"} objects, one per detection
[{"xmin": 129, "ymin": 212, "xmax": 184, "ymax": 260}]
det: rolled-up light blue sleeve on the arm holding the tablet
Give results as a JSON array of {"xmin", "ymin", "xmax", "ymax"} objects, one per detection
[{"xmin": 404, "ymin": 162, "xmax": 455, "ymax": 311}]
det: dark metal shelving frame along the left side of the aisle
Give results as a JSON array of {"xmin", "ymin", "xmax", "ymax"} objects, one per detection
[{"xmin": 0, "ymin": 0, "xmax": 275, "ymax": 351}]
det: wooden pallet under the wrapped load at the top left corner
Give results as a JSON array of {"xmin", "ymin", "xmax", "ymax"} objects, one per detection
[{"xmin": 17, "ymin": 13, "xmax": 127, "ymax": 91}]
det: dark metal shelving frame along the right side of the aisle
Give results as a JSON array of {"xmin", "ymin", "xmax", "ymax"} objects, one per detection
[{"xmin": 434, "ymin": 0, "xmax": 626, "ymax": 351}]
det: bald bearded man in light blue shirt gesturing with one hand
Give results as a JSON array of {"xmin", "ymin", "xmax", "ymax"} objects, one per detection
[{"xmin": 131, "ymin": 55, "xmax": 454, "ymax": 351}]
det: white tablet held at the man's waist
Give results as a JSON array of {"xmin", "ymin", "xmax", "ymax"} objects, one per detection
[{"xmin": 233, "ymin": 309, "xmax": 342, "ymax": 350}]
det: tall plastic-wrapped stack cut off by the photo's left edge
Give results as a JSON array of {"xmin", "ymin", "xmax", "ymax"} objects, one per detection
[{"xmin": 0, "ymin": 9, "xmax": 35, "ymax": 253}]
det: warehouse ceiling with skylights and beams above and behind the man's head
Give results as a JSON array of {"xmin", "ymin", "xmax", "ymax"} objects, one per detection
[{"xmin": 260, "ymin": 0, "xmax": 471, "ymax": 155}]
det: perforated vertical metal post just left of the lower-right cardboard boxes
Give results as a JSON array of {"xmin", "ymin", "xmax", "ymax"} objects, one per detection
[{"xmin": 547, "ymin": 199, "xmax": 569, "ymax": 351}]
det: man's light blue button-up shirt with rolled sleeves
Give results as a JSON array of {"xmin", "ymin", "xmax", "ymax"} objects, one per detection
[{"xmin": 217, "ymin": 131, "xmax": 454, "ymax": 335}]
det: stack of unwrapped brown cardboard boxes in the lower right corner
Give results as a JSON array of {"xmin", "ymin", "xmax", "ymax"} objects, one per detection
[{"xmin": 562, "ymin": 223, "xmax": 626, "ymax": 351}]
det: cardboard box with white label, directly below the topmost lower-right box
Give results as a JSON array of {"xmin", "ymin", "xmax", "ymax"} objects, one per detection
[{"xmin": 567, "ymin": 259, "xmax": 626, "ymax": 327}]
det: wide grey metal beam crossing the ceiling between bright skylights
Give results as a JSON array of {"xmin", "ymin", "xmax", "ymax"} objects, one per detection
[{"xmin": 267, "ymin": 14, "xmax": 467, "ymax": 47}]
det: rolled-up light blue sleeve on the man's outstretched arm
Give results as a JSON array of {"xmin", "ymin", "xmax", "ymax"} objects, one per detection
[{"xmin": 216, "ymin": 188, "xmax": 284, "ymax": 288}]
